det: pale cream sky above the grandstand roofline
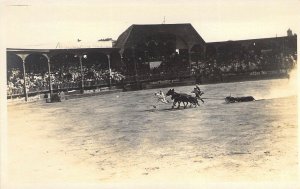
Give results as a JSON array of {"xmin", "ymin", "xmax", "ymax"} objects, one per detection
[{"xmin": 0, "ymin": 0, "xmax": 300, "ymax": 48}]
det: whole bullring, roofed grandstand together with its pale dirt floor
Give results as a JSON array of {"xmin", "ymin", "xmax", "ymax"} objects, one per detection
[{"xmin": 3, "ymin": 24, "xmax": 298, "ymax": 186}]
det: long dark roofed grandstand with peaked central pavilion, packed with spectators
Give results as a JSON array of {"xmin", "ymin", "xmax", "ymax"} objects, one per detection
[{"xmin": 7, "ymin": 24, "xmax": 297, "ymax": 100}]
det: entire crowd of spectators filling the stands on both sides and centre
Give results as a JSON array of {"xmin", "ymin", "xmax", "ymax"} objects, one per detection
[{"xmin": 7, "ymin": 49, "xmax": 297, "ymax": 95}]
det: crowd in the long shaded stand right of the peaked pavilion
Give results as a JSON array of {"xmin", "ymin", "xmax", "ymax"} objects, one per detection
[{"xmin": 193, "ymin": 53, "xmax": 297, "ymax": 78}]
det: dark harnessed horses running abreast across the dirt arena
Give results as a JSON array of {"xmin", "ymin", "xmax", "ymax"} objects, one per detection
[{"xmin": 166, "ymin": 89, "xmax": 199, "ymax": 108}]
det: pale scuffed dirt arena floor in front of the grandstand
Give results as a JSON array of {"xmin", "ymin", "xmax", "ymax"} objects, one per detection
[{"xmin": 3, "ymin": 76, "xmax": 298, "ymax": 188}]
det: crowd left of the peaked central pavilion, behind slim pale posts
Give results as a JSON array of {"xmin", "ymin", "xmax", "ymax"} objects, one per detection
[{"xmin": 7, "ymin": 66, "xmax": 125, "ymax": 96}]
